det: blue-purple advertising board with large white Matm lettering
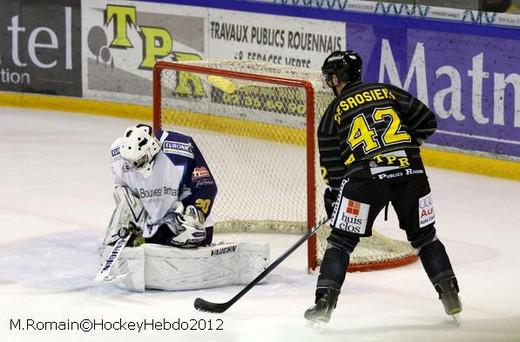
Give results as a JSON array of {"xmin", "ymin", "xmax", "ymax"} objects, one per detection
[{"xmin": 347, "ymin": 24, "xmax": 520, "ymax": 157}]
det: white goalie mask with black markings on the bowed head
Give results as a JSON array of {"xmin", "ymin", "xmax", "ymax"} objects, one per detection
[{"xmin": 120, "ymin": 124, "xmax": 161, "ymax": 177}]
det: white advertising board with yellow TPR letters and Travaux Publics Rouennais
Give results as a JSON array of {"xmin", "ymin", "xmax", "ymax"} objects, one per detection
[{"xmin": 83, "ymin": 0, "xmax": 346, "ymax": 104}]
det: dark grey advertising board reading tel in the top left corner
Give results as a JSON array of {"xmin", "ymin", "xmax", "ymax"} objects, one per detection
[{"xmin": 0, "ymin": 0, "xmax": 82, "ymax": 96}]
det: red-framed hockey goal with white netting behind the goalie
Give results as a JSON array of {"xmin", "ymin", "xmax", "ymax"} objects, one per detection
[{"xmin": 153, "ymin": 60, "xmax": 417, "ymax": 271}]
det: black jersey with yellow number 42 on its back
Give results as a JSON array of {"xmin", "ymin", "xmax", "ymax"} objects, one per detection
[{"xmin": 318, "ymin": 82, "xmax": 437, "ymax": 190}]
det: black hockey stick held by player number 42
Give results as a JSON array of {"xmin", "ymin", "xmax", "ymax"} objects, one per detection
[{"xmin": 193, "ymin": 218, "xmax": 329, "ymax": 313}]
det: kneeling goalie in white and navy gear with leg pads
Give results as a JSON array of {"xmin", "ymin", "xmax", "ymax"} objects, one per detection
[{"xmin": 96, "ymin": 124, "xmax": 269, "ymax": 291}]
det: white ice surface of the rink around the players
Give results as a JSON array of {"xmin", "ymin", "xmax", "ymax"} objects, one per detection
[{"xmin": 0, "ymin": 108, "xmax": 520, "ymax": 342}]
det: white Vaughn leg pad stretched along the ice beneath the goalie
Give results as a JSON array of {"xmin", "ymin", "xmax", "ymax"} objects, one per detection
[{"xmin": 101, "ymin": 242, "xmax": 269, "ymax": 291}]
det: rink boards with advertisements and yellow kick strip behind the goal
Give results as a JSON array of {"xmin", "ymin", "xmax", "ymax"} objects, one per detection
[{"xmin": 0, "ymin": 0, "xmax": 520, "ymax": 179}]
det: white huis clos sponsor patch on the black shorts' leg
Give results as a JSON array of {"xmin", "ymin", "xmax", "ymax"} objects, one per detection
[{"xmin": 332, "ymin": 197, "xmax": 370, "ymax": 235}]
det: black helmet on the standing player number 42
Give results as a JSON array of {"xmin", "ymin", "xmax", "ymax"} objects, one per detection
[{"xmin": 321, "ymin": 50, "xmax": 363, "ymax": 88}]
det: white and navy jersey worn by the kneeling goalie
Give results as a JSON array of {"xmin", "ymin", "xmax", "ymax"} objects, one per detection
[{"xmin": 111, "ymin": 131, "xmax": 217, "ymax": 237}]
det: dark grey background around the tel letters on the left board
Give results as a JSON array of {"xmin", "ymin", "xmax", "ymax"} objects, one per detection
[{"xmin": 0, "ymin": 0, "xmax": 82, "ymax": 96}]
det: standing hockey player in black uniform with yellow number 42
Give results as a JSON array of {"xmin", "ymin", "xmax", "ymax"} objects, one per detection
[{"xmin": 304, "ymin": 50, "xmax": 462, "ymax": 322}]
